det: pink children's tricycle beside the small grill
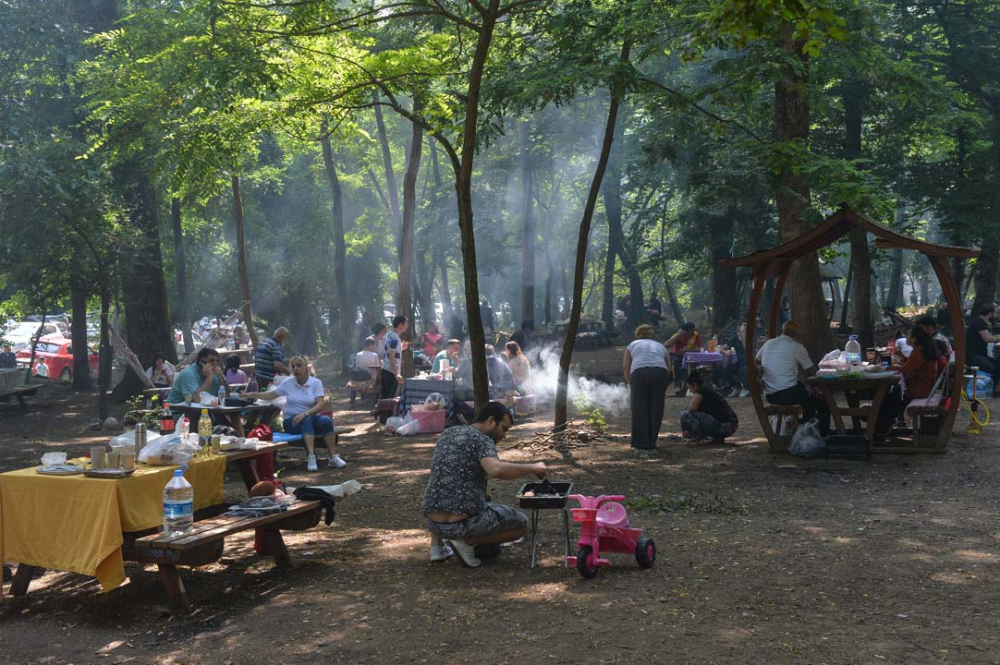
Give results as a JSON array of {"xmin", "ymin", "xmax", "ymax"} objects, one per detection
[{"xmin": 566, "ymin": 494, "xmax": 656, "ymax": 579}]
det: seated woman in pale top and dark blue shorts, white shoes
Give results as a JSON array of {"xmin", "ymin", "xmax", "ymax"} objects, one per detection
[{"xmin": 246, "ymin": 356, "xmax": 347, "ymax": 471}]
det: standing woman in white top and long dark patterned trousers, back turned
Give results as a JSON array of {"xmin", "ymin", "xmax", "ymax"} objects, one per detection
[{"xmin": 622, "ymin": 325, "xmax": 670, "ymax": 450}]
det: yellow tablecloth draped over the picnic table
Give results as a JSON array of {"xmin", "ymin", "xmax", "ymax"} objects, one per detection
[{"xmin": 0, "ymin": 457, "xmax": 226, "ymax": 591}]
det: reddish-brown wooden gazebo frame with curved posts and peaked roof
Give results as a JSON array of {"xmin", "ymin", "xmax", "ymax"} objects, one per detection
[{"xmin": 722, "ymin": 206, "xmax": 979, "ymax": 452}]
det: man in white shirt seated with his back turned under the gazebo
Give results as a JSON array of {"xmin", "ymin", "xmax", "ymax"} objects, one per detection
[{"xmin": 757, "ymin": 321, "xmax": 830, "ymax": 436}]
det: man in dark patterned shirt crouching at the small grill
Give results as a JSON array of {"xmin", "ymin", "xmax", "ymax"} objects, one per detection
[{"xmin": 422, "ymin": 402, "xmax": 547, "ymax": 568}]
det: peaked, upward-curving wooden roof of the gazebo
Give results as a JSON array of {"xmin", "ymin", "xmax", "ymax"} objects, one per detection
[{"xmin": 722, "ymin": 206, "xmax": 979, "ymax": 268}]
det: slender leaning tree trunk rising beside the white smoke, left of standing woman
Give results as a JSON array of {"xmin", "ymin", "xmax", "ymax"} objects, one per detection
[{"xmin": 552, "ymin": 40, "xmax": 632, "ymax": 432}]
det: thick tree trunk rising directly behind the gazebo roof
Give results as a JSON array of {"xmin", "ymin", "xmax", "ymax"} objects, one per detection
[{"xmin": 774, "ymin": 24, "xmax": 834, "ymax": 362}]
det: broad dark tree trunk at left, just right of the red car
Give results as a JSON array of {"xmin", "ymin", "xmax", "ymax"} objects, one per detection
[{"xmin": 114, "ymin": 162, "xmax": 177, "ymax": 401}]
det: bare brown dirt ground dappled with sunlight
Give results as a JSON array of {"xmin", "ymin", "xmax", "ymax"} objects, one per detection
[{"xmin": 0, "ymin": 350, "xmax": 1000, "ymax": 665}]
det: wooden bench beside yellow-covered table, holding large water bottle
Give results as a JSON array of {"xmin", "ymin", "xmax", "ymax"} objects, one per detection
[{"xmin": 122, "ymin": 501, "xmax": 322, "ymax": 614}]
